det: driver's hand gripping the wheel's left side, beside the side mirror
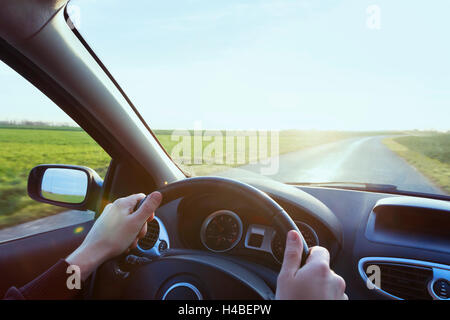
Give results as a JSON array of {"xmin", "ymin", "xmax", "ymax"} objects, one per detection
[{"xmin": 66, "ymin": 192, "xmax": 162, "ymax": 280}]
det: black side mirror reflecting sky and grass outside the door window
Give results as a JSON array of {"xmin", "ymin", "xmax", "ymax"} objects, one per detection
[{"xmin": 28, "ymin": 164, "xmax": 103, "ymax": 211}]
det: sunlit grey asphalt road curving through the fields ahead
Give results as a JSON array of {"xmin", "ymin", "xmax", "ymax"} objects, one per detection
[{"xmin": 220, "ymin": 136, "xmax": 446, "ymax": 194}]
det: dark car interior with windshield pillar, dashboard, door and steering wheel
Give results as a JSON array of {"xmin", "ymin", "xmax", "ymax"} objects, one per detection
[{"xmin": 0, "ymin": 0, "xmax": 450, "ymax": 300}]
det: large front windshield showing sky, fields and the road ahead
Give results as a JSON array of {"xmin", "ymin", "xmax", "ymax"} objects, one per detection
[{"xmin": 68, "ymin": 0, "xmax": 450, "ymax": 195}]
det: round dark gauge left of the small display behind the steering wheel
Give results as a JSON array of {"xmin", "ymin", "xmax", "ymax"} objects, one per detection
[{"xmin": 200, "ymin": 210, "xmax": 243, "ymax": 252}]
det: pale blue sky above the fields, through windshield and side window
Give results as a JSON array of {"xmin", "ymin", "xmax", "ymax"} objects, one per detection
[{"xmin": 0, "ymin": 0, "xmax": 450, "ymax": 130}]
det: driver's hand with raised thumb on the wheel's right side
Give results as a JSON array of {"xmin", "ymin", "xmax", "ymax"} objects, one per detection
[{"xmin": 275, "ymin": 230, "xmax": 348, "ymax": 300}]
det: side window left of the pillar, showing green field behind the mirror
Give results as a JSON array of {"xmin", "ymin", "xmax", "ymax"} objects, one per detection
[{"xmin": 0, "ymin": 62, "xmax": 111, "ymax": 242}]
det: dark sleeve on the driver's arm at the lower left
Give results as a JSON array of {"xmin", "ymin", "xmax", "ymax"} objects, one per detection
[{"xmin": 4, "ymin": 259, "xmax": 81, "ymax": 300}]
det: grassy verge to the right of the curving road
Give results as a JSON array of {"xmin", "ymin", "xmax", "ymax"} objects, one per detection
[{"xmin": 383, "ymin": 133, "xmax": 450, "ymax": 194}]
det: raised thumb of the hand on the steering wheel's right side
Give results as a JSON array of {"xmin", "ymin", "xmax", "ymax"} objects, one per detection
[{"xmin": 280, "ymin": 230, "xmax": 303, "ymax": 276}]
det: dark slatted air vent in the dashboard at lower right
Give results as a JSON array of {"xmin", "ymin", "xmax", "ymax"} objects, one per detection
[{"xmin": 363, "ymin": 261, "xmax": 433, "ymax": 300}]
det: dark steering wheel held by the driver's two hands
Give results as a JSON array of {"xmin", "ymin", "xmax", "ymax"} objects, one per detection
[{"xmin": 95, "ymin": 177, "xmax": 309, "ymax": 300}]
